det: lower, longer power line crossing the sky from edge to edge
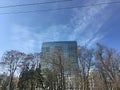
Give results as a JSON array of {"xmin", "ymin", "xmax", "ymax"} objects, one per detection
[{"xmin": 0, "ymin": 2, "xmax": 120, "ymax": 14}]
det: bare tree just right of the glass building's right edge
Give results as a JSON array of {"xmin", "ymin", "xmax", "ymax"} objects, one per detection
[{"xmin": 78, "ymin": 47, "xmax": 94, "ymax": 90}]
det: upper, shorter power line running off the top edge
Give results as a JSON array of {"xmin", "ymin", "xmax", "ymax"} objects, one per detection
[{"xmin": 0, "ymin": 0, "xmax": 72, "ymax": 8}]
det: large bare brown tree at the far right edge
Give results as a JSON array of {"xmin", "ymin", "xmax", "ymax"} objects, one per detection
[{"xmin": 96, "ymin": 44, "xmax": 120, "ymax": 90}]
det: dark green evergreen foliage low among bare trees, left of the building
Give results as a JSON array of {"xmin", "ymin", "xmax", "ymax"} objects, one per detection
[{"xmin": 18, "ymin": 65, "xmax": 44, "ymax": 90}]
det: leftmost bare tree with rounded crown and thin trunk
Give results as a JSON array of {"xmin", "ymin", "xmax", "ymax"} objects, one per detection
[{"xmin": 0, "ymin": 50, "xmax": 25, "ymax": 90}]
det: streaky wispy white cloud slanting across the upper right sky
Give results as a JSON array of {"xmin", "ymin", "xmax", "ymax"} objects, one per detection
[{"xmin": 69, "ymin": 0, "xmax": 111, "ymax": 46}]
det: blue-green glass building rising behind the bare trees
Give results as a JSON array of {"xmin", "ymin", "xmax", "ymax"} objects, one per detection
[{"xmin": 41, "ymin": 41, "xmax": 78, "ymax": 74}]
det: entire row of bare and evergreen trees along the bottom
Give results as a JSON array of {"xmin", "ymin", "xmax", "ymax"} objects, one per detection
[{"xmin": 0, "ymin": 43, "xmax": 120, "ymax": 90}]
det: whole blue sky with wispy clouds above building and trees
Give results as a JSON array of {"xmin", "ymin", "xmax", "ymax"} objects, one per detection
[{"xmin": 0, "ymin": 0, "xmax": 120, "ymax": 55}]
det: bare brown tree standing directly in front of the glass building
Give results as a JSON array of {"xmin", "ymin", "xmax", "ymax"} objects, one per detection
[{"xmin": 42, "ymin": 50, "xmax": 65, "ymax": 90}]
